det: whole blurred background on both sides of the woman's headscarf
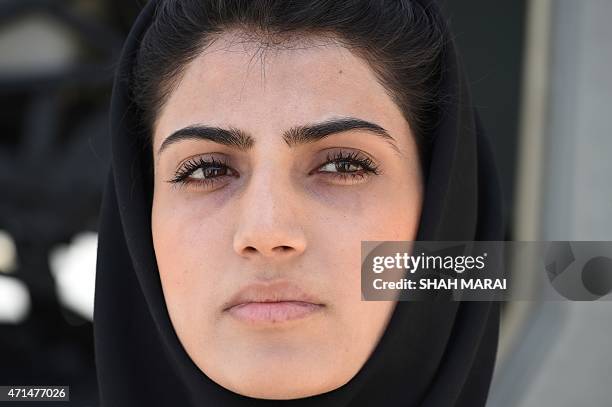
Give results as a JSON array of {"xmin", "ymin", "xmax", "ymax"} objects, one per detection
[{"xmin": 0, "ymin": 0, "xmax": 612, "ymax": 407}]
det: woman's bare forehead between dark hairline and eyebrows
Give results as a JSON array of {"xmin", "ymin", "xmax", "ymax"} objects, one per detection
[{"xmin": 155, "ymin": 32, "xmax": 402, "ymax": 145}]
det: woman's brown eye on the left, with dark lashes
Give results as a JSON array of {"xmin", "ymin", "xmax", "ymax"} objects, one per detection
[{"xmin": 167, "ymin": 157, "xmax": 238, "ymax": 188}]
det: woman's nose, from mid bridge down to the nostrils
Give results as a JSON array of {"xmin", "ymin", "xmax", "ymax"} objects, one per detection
[{"xmin": 233, "ymin": 171, "xmax": 306, "ymax": 260}]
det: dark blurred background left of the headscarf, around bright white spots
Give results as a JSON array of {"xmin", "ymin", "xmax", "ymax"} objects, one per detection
[{"xmin": 0, "ymin": 0, "xmax": 138, "ymax": 405}]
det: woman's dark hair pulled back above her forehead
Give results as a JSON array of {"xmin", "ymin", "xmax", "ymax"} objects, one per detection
[{"xmin": 131, "ymin": 0, "xmax": 447, "ymax": 169}]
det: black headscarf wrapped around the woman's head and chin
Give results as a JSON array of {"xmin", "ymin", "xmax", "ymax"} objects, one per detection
[{"xmin": 94, "ymin": 0, "xmax": 503, "ymax": 407}]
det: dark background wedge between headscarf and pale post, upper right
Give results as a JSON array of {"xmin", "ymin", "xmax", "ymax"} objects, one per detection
[{"xmin": 442, "ymin": 0, "xmax": 526, "ymax": 239}]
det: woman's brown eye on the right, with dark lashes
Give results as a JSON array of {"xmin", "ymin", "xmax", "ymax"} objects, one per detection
[{"xmin": 317, "ymin": 151, "xmax": 379, "ymax": 181}]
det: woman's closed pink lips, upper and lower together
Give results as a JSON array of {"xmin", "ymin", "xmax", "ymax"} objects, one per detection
[{"xmin": 223, "ymin": 281, "xmax": 325, "ymax": 325}]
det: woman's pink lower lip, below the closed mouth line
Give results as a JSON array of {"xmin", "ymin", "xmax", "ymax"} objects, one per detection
[{"xmin": 228, "ymin": 301, "xmax": 323, "ymax": 323}]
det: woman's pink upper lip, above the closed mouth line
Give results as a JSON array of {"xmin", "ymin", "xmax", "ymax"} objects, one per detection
[{"xmin": 223, "ymin": 281, "xmax": 323, "ymax": 311}]
